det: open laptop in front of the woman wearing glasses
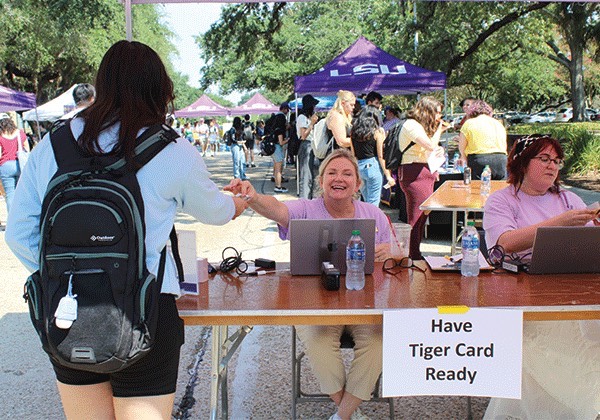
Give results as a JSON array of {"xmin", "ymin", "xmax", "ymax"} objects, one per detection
[{"xmin": 529, "ymin": 226, "xmax": 600, "ymax": 274}]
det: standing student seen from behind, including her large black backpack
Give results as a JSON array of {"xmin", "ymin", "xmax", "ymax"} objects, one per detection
[{"xmin": 5, "ymin": 41, "xmax": 246, "ymax": 419}]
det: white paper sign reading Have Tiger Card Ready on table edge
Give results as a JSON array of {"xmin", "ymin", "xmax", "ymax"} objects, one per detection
[{"xmin": 383, "ymin": 308, "xmax": 523, "ymax": 398}]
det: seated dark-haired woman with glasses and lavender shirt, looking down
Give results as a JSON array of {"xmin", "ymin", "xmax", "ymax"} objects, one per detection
[{"xmin": 483, "ymin": 135, "xmax": 600, "ymax": 419}]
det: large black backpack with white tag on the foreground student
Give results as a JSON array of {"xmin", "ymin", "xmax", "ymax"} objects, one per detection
[{"xmin": 24, "ymin": 121, "xmax": 183, "ymax": 373}]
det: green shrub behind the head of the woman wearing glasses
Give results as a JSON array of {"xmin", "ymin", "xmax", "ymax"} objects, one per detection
[{"xmin": 509, "ymin": 122, "xmax": 600, "ymax": 175}]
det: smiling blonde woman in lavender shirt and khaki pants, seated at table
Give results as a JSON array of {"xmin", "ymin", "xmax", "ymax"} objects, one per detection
[{"xmin": 224, "ymin": 149, "xmax": 390, "ymax": 419}]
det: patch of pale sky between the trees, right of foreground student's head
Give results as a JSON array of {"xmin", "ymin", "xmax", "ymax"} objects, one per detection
[{"xmin": 162, "ymin": 3, "xmax": 241, "ymax": 104}]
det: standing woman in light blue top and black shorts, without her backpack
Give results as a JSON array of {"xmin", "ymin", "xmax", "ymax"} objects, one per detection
[{"xmin": 5, "ymin": 41, "xmax": 246, "ymax": 419}]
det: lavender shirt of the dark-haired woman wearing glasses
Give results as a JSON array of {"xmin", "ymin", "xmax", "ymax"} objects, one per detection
[{"xmin": 483, "ymin": 185, "xmax": 593, "ymax": 254}]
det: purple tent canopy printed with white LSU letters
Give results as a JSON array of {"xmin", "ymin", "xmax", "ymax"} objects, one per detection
[{"xmin": 294, "ymin": 36, "xmax": 446, "ymax": 95}]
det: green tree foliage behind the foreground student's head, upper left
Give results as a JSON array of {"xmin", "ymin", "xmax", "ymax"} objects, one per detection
[{"xmin": 0, "ymin": 0, "xmax": 197, "ymax": 111}]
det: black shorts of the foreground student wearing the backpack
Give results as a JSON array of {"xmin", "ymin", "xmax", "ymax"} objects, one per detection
[{"xmin": 50, "ymin": 294, "xmax": 184, "ymax": 397}]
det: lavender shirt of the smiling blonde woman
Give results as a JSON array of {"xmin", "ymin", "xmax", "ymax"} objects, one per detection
[{"xmin": 277, "ymin": 197, "xmax": 390, "ymax": 244}]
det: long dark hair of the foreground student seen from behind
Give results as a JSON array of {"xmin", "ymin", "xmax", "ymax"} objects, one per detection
[{"xmin": 77, "ymin": 41, "xmax": 175, "ymax": 158}]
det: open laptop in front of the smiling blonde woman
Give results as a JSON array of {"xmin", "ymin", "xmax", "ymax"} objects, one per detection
[{"xmin": 290, "ymin": 219, "xmax": 375, "ymax": 275}]
